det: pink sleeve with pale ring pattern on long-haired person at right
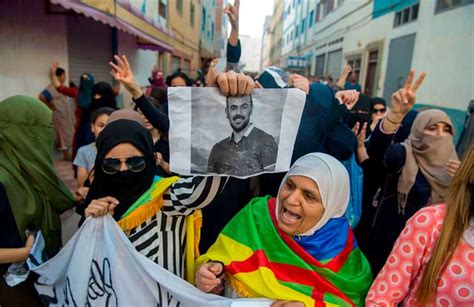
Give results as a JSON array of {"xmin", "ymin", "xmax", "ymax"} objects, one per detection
[{"xmin": 365, "ymin": 207, "xmax": 442, "ymax": 306}]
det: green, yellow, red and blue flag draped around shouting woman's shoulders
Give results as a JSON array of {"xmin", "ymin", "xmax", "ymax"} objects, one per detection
[{"xmin": 198, "ymin": 198, "xmax": 372, "ymax": 306}]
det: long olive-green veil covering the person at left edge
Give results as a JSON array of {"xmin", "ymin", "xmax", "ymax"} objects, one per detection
[{"xmin": 0, "ymin": 96, "xmax": 74, "ymax": 256}]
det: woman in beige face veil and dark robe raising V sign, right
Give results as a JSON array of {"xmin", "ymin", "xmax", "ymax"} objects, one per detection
[{"xmin": 366, "ymin": 70, "xmax": 459, "ymax": 274}]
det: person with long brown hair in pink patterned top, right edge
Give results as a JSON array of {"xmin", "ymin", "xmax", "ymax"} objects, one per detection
[{"xmin": 366, "ymin": 144, "xmax": 474, "ymax": 306}]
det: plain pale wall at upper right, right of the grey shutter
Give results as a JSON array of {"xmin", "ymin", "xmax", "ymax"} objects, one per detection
[{"xmin": 400, "ymin": 1, "xmax": 474, "ymax": 110}]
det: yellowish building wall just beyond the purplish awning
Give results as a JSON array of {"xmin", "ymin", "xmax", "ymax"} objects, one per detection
[{"xmin": 165, "ymin": 0, "xmax": 201, "ymax": 78}]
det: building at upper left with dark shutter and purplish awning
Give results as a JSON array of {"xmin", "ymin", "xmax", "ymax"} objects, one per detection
[{"xmin": 0, "ymin": 0, "xmax": 173, "ymax": 106}]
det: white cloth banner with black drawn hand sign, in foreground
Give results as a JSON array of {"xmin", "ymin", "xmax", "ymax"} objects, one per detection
[{"xmin": 33, "ymin": 215, "xmax": 271, "ymax": 307}]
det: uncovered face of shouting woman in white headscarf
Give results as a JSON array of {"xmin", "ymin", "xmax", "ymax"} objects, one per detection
[{"xmin": 278, "ymin": 176, "xmax": 324, "ymax": 235}]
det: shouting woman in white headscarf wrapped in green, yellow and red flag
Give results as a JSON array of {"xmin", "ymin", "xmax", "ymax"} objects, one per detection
[{"xmin": 196, "ymin": 153, "xmax": 372, "ymax": 306}]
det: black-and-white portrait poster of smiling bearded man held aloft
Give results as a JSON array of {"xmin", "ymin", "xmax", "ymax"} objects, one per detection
[{"xmin": 168, "ymin": 87, "xmax": 306, "ymax": 178}]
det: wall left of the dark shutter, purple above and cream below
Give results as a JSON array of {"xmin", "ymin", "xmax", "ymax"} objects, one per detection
[{"xmin": 0, "ymin": 0, "xmax": 68, "ymax": 99}]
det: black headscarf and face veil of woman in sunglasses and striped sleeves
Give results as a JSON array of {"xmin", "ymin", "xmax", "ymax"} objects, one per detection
[{"xmin": 85, "ymin": 119, "xmax": 155, "ymax": 220}]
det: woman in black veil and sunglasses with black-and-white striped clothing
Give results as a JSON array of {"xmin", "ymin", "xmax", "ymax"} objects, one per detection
[{"xmin": 85, "ymin": 118, "xmax": 225, "ymax": 278}]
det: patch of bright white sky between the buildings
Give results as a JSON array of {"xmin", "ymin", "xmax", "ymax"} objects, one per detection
[{"xmin": 237, "ymin": 0, "xmax": 273, "ymax": 38}]
